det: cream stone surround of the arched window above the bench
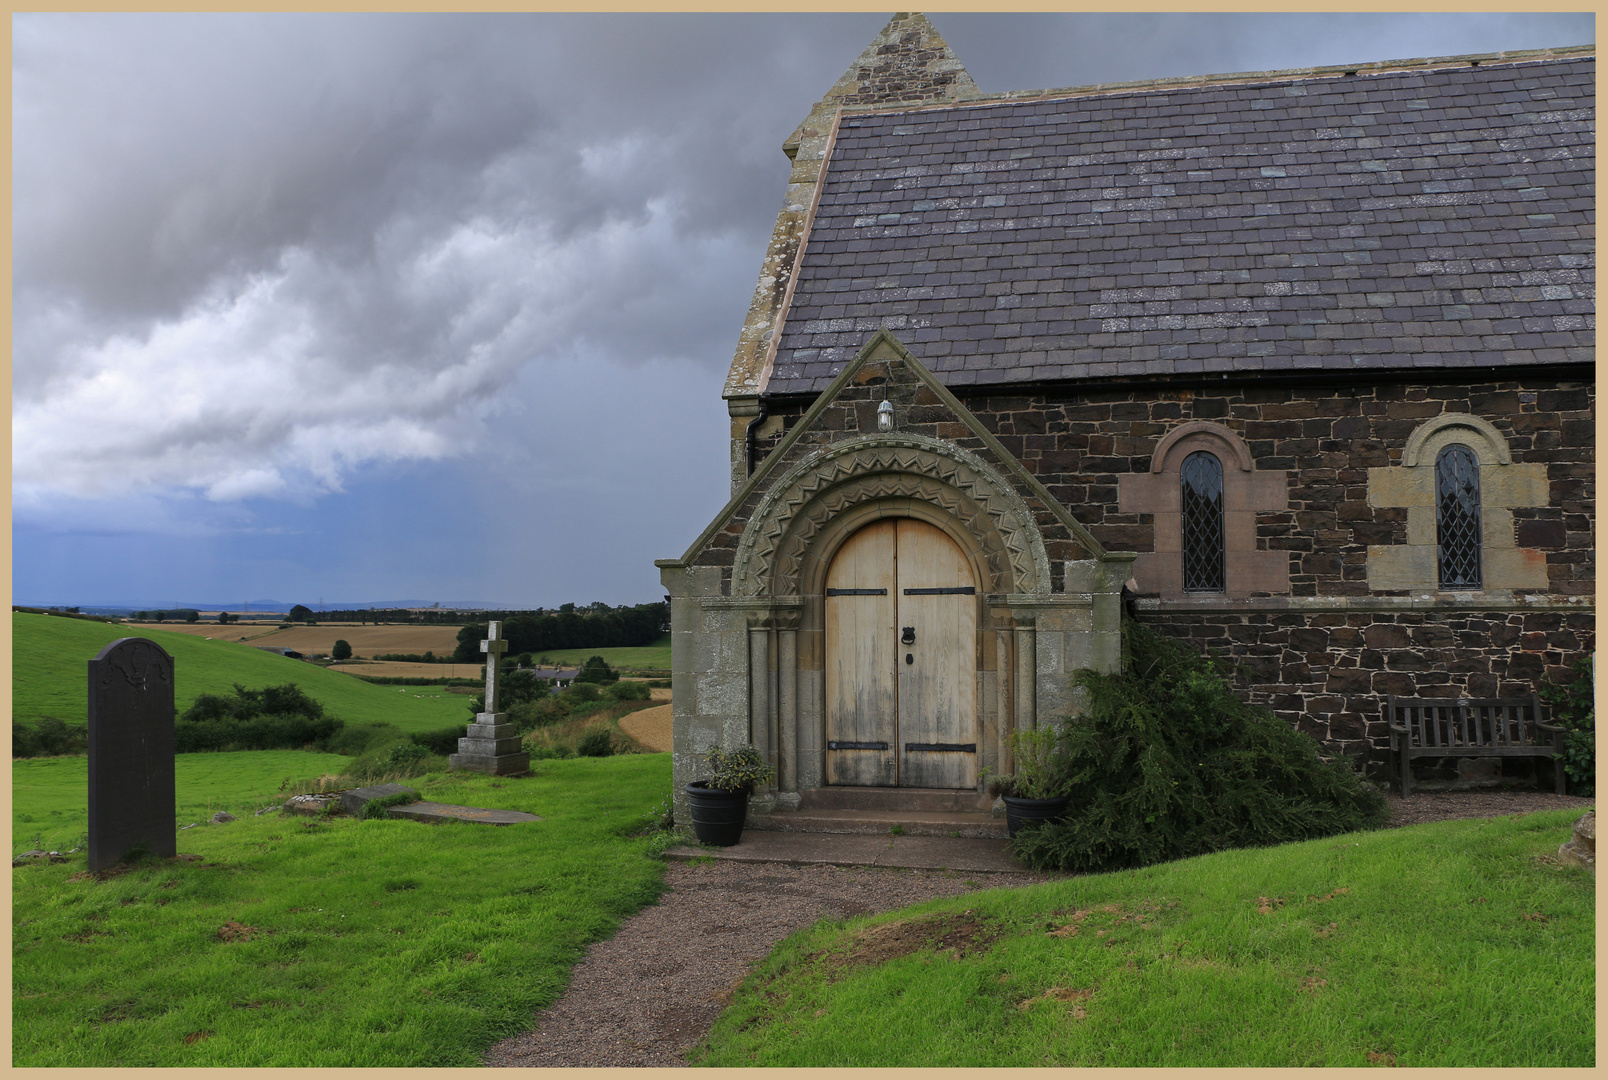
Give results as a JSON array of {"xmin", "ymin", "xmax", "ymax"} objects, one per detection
[{"xmin": 1368, "ymin": 413, "xmax": 1550, "ymax": 596}]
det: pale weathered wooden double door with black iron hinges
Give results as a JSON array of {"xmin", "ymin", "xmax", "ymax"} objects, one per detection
[{"xmin": 825, "ymin": 518, "xmax": 978, "ymax": 788}]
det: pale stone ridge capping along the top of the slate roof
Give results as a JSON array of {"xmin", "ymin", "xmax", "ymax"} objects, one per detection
[{"xmin": 843, "ymin": 42, "xmax": 1597, "ymax": 116}]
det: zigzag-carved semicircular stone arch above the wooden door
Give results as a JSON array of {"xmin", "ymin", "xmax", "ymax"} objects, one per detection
[{"xmin": 732, "ymin": 434, "xmax": 1050, "ymax": 596}]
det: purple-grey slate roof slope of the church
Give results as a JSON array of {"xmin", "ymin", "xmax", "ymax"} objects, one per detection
[{"xmin": 765, "ymin": 56, "xmax": 1595, "ymax": 394}]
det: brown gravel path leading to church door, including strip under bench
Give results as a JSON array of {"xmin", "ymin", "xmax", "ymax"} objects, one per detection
[{"xmin": 486, "ymin": 791, "xmax": 1595, "ymax": 1067}]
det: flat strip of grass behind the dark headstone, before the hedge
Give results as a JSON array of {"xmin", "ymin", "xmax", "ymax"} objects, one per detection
[{"xmin": 11, "ymin": 751, "xmax": 352, "ymax": 852}]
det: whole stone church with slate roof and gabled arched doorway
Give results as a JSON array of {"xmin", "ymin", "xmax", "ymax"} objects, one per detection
[{"xmin": 658, "ymin": 14, "xmax": 1595, "ymax": 824}]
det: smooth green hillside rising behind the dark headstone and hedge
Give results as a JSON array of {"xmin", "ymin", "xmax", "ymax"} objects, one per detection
[{"xmin": 11, "ymin": 612, "xmax": 470, "ymax": 731}]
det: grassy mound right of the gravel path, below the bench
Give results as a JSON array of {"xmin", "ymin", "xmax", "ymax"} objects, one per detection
[{"xmin": 693, "ymin": 810, "xmax": 1595, "ymax": 1069}]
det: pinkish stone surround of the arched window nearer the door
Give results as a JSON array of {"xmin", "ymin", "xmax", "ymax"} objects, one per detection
[{"xmin": 1118, "ymin": 419, "xmax": 1290, "ymax": 599}]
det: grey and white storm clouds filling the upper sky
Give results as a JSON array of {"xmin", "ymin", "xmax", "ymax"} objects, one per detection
[{"xmin": 13, "ymin": 14, "xmax": 1592, "ymax": 514}]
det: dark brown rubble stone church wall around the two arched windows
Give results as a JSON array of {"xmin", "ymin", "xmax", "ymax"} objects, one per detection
[{"xmin": 757, "ymin": 376, "xmax": 1595, "ymax": 759}]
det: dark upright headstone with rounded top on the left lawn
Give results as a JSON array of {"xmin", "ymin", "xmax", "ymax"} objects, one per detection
[{"xmin": 88, "ymin": 638, "xmax": 178, "ymax": 871}]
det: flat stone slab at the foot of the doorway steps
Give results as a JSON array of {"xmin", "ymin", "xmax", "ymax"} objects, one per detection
[{"xmin": 664, "ymin": 829, "xmax": 1029, "ymax": 874}]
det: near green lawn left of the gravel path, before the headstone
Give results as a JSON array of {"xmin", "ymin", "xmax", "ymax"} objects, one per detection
[{"xmin": 11, "ymin": 755, "xmax": 671, "ymax": 1067}]
